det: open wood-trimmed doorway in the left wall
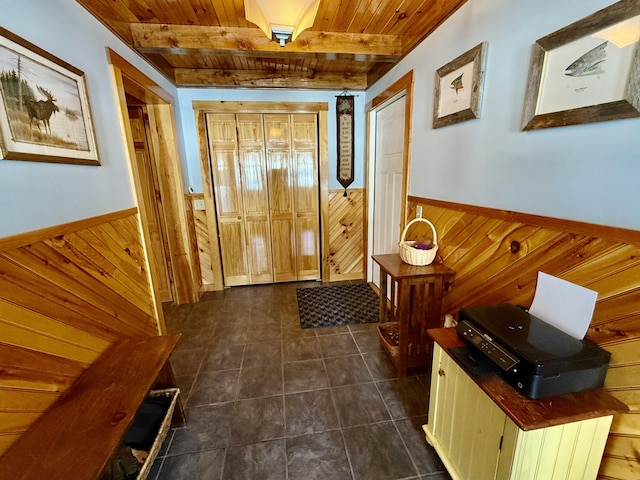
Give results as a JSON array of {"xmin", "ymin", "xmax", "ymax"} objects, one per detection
[{"xmin": 107, "ymin": 49, "xmax": 201, "ymax": 314}]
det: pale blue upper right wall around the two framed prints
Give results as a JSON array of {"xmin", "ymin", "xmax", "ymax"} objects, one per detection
[{"xmin": 366, "ymin": 0, "xmax": 640, "ymax": 230}]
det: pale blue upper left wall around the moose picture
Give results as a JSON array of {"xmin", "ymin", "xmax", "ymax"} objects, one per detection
[{"xmin": 0, "ymin": 0, "xmax": 177, "ymax": 238}]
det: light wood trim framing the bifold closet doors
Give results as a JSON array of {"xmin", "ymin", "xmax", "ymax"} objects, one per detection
[{"xmin": 192, "ymin": 100, "xmax": 330, "ymax": 290}]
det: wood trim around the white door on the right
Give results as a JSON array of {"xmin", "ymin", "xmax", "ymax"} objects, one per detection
[{"xmin": 363, "ymin": 70, "xmax": 413, "ymax": 278}]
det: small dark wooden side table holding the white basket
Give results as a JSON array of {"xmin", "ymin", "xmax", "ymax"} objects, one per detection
[{"xmin": 372, "ymin": 254, "xmax": 454, "ymax": 376}]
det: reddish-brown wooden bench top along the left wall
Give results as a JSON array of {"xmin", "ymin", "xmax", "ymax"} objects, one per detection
[{"xmin": 0, "ymin": 334, "xmax": 183, "ymax": 480}]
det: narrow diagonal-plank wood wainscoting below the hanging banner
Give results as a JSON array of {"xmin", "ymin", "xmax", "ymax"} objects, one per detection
[{"xmin": 325, "ymin": 188, "xmax": 365, "ymax": 282}]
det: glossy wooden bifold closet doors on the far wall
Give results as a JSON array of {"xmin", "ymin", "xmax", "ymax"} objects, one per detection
[{"xmin": 207, "ymin": 114, "xmax": 320, "ymax": 286}]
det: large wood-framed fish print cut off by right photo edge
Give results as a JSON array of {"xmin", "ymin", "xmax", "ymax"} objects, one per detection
[{"xmin": 522, "ymin": 0, "xmax": 640, "ymax": 130}]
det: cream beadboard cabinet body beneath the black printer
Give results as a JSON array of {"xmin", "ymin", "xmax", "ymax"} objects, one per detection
[{"xmin": 423, "ymin": 343, "xmax": 613, "ymax": 480}]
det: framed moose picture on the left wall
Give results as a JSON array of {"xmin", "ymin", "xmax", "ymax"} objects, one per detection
[{"xmin": 0, "ymin": 27, "xmax": 100, "ymax": 165}]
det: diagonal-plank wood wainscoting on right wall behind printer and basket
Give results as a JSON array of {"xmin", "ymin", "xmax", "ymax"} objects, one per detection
[{"xmin": 407, "ymin": 197, "xmax": 640, "ymax": 480}]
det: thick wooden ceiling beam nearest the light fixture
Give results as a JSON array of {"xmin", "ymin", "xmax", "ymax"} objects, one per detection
[{"xmin": 131, "ymin": 23, "xmax": 402, "ymax": 62}]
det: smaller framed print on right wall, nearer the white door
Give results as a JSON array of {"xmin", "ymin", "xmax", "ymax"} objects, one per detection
[{"xmin": 433, "ymin": 42, "xmax": 487, "ymax": 128}]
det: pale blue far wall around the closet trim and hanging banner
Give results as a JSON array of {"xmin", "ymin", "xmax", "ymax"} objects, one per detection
[{"xmin": 178, "ymin": 88, "xmax": 366, "ymax": 193}]
